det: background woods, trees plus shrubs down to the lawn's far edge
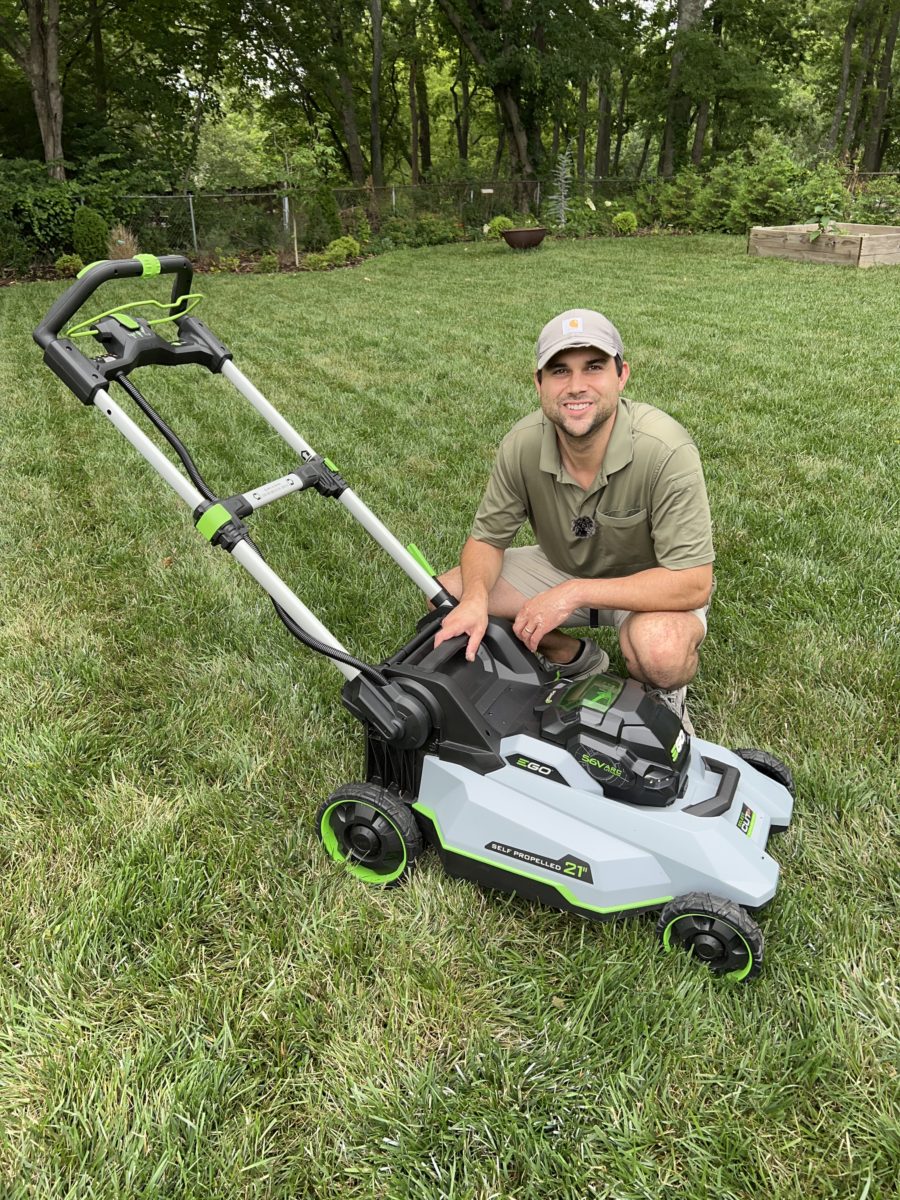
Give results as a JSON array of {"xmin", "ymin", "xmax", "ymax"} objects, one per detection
[{"xmin": 0, "ymin": 0, "xmax": 900, "ymax": 269}]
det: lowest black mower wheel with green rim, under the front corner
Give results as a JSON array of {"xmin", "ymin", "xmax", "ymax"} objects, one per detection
[{"xmin": 656, "ymin": 892, "xmax": 763, "ymax": 982}]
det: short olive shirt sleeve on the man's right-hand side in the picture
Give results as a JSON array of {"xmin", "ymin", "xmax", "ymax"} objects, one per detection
[{"xmin": 650, "ymin": 445, "xmax": 715, "ymax": 571}]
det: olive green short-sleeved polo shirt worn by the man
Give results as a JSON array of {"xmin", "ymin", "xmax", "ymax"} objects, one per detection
[{"xmin": 472, "ymin": 396, "xmax": 715, "ymax": 578}]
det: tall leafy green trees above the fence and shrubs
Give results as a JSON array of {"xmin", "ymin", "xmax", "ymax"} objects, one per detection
[{"xmin": 0, "ymin": 0, "xmax": 900, "ymax": 188}]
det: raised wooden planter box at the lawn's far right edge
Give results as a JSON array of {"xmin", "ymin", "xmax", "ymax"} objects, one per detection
[{"xmin": 746, "ymin": 221, "xmax": 900, "ymax": 266}]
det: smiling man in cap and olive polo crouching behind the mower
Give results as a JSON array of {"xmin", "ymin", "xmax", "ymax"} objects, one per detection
[{"xmin": 434, "ymin": 308, "xmax": 714, "ymax": 732}]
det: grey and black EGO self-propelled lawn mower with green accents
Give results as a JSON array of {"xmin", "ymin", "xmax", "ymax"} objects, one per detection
[{"xmin": 34, "ymin": 254, "xmax": 793, "ymax": 980}]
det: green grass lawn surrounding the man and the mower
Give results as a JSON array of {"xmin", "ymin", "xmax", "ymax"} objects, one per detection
[{"xmin": 0, "ymin": 236, "xmax": 900, "ymax": 1200}]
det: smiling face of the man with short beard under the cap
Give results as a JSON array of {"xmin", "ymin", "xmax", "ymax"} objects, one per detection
[{"xmin": 534, "ymin": 347, "xmax": 629, "ymax": 439}]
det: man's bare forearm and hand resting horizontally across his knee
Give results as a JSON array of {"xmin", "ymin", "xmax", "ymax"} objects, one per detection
[{"xmin": 512, "ymin": 563, "xmax": 713, "ymax": 650}]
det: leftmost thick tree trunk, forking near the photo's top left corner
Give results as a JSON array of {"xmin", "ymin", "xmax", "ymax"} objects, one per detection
[{"xmin": 0, "ymin": 0, "xmax": 66, "ymax": 180}]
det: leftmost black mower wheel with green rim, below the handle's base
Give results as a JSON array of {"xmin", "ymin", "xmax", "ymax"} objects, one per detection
[{"xmin": 316, "ymin": 784, "xmax": 422, "ymax": 887}]
